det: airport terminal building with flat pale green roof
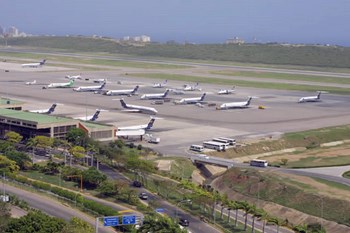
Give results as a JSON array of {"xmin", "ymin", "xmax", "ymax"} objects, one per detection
[{"xmin": 0, "ymin": 108, "xmax": 116, "ymax": 141}]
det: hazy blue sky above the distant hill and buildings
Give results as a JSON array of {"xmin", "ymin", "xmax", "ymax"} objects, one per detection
[{"xmin": 0, "ymin": 0, "xmax": 350, "ymax": 46}]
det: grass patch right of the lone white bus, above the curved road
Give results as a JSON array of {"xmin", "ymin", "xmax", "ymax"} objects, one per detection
[{"xmin": 287, "ymin": 156, "xmax": 350, "ymax": 168}]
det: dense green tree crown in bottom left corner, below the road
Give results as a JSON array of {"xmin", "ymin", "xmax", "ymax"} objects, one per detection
[{"xmin": 4, "ymin": 211, "xmax": 66, "ymax": 233}]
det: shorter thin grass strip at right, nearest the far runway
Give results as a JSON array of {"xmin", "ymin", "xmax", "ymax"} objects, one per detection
[{"xmin": 210, "ymin": 71, "xmax": 350, "ymax": 84}]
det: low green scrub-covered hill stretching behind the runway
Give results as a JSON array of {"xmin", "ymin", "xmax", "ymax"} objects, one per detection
[{"xmin": 0, "ymin": 37, "xmax": 350, "ymax": 68}]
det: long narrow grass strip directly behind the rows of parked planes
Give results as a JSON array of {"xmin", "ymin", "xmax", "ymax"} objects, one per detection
[{"xmin": 128, "ymin": 73, "xmax": 350, "ymax": 94}]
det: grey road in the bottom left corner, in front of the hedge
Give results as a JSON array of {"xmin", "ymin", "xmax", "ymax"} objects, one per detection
[{"xmin": 5, "ymin": 184, "xmax": 116, "ymax": 233}]
